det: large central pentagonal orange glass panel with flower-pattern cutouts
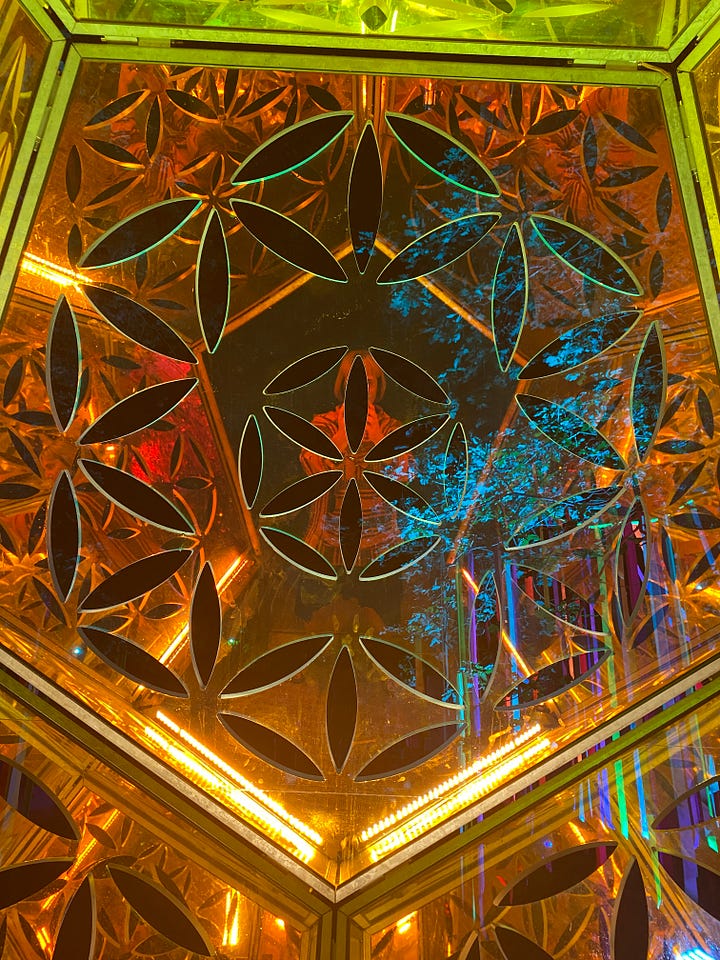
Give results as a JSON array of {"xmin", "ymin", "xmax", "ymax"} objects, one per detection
[{"xmin": 0, "ymin": 63, "xmax": 720, "ymax": 882}]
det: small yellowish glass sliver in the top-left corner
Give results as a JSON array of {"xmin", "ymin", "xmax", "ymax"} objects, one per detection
[{"xmin": 0, "ymin": 0, "xmax": 49, "ymax": 199}]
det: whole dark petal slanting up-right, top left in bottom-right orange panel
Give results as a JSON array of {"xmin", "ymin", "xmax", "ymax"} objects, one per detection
[{"xmin": 495, "ymin": 840, "xmax": 617, "ymax": 907}]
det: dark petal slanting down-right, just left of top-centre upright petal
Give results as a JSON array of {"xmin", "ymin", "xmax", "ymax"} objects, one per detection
[{"xmin": 230, "ymin": 200, "xmax": 347, "ymax": 283}]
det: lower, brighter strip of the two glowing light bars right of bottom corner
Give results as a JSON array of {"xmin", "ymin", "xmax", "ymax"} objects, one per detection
[{"xmin": 370, "ymin": 737, "xmax": 552, "ymax": 862}]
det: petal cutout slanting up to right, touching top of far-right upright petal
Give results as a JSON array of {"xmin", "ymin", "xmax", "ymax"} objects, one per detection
[{"xmin": 518, "ymin": 310, "xmax": 643, "ymax": 380}]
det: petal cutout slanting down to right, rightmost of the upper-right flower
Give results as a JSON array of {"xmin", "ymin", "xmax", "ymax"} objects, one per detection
[{"xmin": 530, "ymin": 214, "xmax": 643, "ymax": 297}]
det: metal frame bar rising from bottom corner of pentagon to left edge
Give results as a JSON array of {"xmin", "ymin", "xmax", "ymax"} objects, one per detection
[{"xmin": 0, "ymin": 646, "xmax": 335, "ymax": 908}]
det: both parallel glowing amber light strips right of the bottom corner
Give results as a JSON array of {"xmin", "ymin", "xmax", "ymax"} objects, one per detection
[{"xmin": 361, "ymin": 724, "xmax": 552, "ymax": 861}]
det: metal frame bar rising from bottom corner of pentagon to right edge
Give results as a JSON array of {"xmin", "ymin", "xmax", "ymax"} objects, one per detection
[{"xmin": 336, "ymin": 654, "xmax": 720, "ymax": 908}]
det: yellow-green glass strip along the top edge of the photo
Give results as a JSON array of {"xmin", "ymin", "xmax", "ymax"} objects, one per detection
[{"xmin": 66, "ymin": 0, "xmax": 705, "ymax": 48}]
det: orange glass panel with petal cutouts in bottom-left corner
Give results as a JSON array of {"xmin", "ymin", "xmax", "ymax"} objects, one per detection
[{"xmin": 0, "ymin": 699, "xmax": 304, "ymax": 960}]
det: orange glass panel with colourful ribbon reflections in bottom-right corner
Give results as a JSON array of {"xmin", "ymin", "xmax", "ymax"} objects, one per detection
[{"xmin": 370, "ymin": 703, "xmax": 720, "ymax": 960}]
